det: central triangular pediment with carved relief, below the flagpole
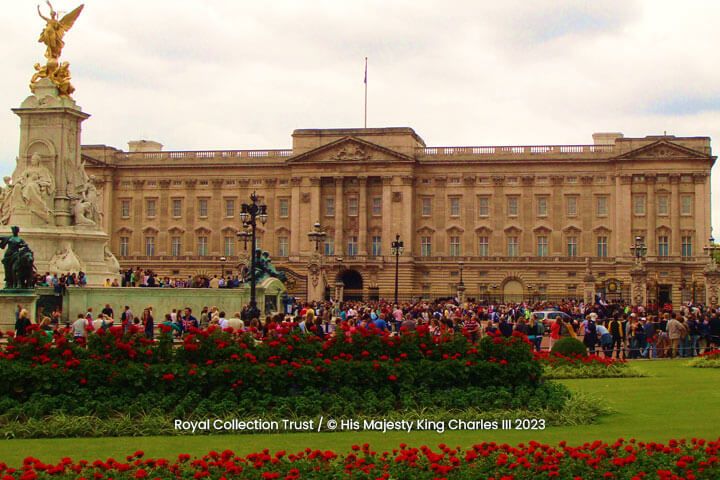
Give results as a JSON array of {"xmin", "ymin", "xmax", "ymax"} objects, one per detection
[{"xmin": 288, "ymin": 137, "xmax": 415, "ymax": 164}]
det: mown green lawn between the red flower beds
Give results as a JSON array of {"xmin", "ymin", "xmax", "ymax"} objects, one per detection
[{"xmin": 0, "ymin": 360, "xmax": 720, "ymax": 465}]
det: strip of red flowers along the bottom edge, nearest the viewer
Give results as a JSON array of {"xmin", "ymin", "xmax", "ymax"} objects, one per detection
[{"xmin": 5, "ymin": 439, "xmax": 720, "ymax": 480}]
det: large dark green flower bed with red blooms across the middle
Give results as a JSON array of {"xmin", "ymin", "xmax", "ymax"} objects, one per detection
[{"xmin": 0, "ymin": 328, "xmax": 569, "ymax": 424}]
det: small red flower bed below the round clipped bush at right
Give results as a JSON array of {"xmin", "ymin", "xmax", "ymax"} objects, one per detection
[{"xmin": 534, "ymin": 352, "xmax": 643, "ymax": 379}]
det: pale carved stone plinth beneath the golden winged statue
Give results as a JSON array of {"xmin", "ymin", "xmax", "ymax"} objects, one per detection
[{"xmin": 0, "ymin": 78, "xmax": 120, "ymax": 285}]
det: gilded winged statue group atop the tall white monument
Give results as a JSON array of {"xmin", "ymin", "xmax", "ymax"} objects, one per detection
[{"xmin": 30, "ymin": 0, "xmax": 84, "ymax": 97}]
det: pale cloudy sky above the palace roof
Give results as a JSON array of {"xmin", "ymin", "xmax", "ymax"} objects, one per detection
[{"xmin": 0, "ymin": 0, "xmax": 720, "ymax": 235}]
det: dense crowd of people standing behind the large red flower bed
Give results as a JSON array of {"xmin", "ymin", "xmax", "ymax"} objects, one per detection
[{"xmin": 11, "ymin": 299, "xmax": 720, "ymax": 359}]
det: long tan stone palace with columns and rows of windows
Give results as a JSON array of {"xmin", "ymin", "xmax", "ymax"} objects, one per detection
[{"xmin": 82, "ymin": 128, "xmax": 715, "ymax": 303}]
